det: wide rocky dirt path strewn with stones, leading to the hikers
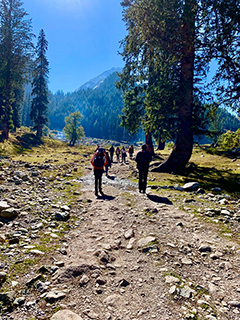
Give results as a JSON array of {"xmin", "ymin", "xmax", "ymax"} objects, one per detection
[{"xmin": 0, "ymin": 158, "xmax": 240, "ymax": 320}]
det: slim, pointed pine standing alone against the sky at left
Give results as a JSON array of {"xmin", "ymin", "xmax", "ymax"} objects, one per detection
[{"xmin": 30, "ymin": 29, "xmax": 49, "ymax": 138}]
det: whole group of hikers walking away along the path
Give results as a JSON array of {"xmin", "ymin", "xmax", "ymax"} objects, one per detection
[{"xmin": 91, "ymin": 144, "xmax": 152, "ymax": 197}]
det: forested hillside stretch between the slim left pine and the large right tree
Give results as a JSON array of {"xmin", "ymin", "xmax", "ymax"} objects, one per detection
[{"xmin": 46, "ymin": 73, "xmax": 136, "ymax": 140}]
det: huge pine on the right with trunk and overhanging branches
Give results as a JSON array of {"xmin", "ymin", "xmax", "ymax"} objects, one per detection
[{"xmin": 118, "ymin": 0, "xmax": 239, "ymax": 172}]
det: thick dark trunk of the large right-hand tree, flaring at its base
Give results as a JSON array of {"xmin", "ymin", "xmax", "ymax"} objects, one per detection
[{"xmin": 152, "ymin": 0, "xmax": 196, "ymax": 173}]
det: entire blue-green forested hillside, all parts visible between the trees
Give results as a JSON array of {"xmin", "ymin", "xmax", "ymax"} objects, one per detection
[{"xmin": 19, "ymin": 72, "xmax": 240, "ymax": 143}]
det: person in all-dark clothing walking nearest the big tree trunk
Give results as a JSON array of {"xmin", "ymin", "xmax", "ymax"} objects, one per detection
[{"xmin": 135, "ymin": 144, "xmax": 152, "ymax": 193}]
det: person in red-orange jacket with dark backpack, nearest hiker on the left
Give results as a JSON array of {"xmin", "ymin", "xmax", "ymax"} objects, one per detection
[{"xmin": 91, "ymin": 147, "xmax": 107, "ymax": 196}]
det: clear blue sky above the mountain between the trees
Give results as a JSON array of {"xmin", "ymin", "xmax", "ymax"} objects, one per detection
[{"xmin": 23, "ymin": 0, "xmax": 126, "ymax": 93}]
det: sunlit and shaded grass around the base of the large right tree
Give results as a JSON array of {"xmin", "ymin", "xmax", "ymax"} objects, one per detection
[{"xmin": 152, "ymin": 147, "xmax": 240, "ymax": 199}]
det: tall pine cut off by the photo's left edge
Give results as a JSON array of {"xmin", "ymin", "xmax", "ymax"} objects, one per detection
[{"xmin": 0, "ymin": 0, "xmax": 34, "ymax": 139}]
